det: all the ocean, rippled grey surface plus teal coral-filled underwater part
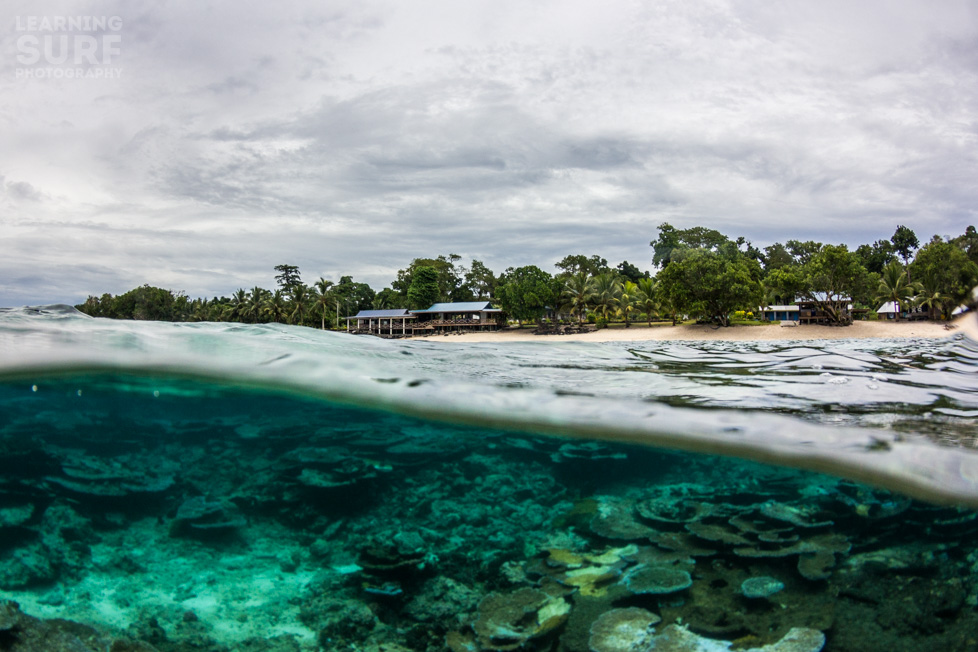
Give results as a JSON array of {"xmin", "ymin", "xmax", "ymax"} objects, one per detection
[{"xmin": 0, "ymin": 306, "xmax": 978, "ymax": 652}]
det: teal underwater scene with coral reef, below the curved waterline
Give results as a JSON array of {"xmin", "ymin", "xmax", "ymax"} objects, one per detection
[{"xmin": 0, "ymin": 375, "xmax": 978, "ymax": 652}]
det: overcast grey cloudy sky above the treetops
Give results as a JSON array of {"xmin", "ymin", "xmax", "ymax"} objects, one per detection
[{"xmin": 0, "ymin": 0, "xmax": 978, "ymax": 306}]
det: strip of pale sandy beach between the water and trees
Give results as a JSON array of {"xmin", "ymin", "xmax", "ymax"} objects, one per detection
[{"xmin": 411, "ymin": 321, "xmax": 962, "ymax": 342}]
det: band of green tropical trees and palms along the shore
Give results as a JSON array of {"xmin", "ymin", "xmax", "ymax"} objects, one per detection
[{"xmin": 76, "ymin": 223, "xmax": 978, "ymax": 329}]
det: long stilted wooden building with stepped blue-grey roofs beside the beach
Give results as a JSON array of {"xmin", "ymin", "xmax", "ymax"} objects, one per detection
[{"xmin": 346, "ymin": 301, "xmax": 502, "ymax": 337}]
